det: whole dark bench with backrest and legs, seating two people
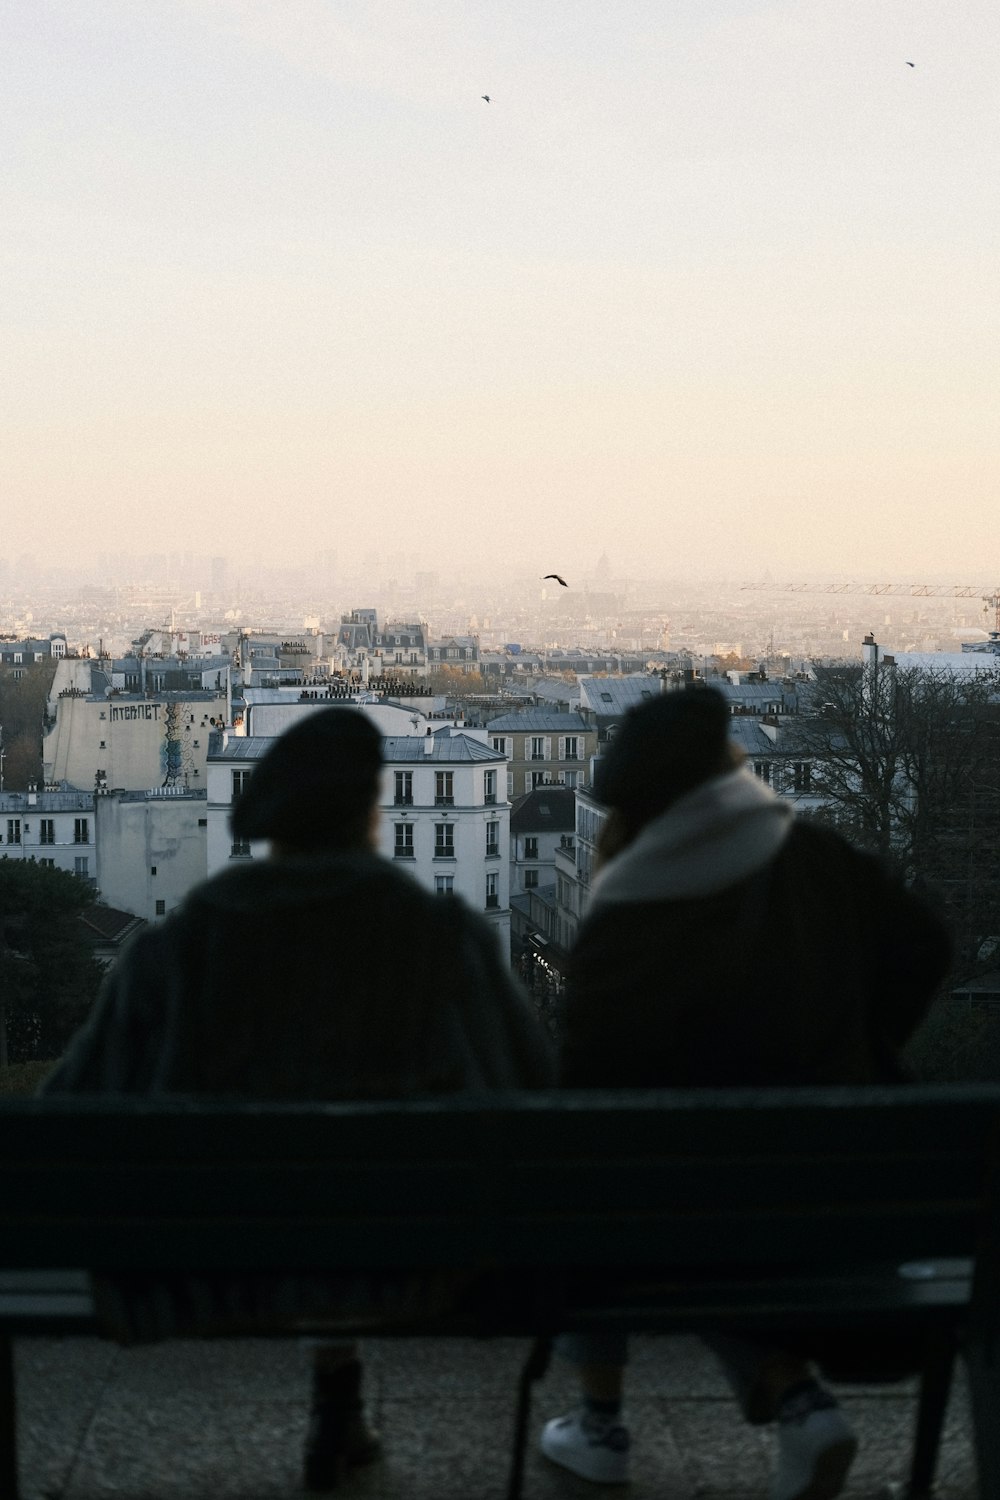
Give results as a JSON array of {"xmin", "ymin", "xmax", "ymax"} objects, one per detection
[{"xmin": 0, "ymin": 1086, "xmax": 1000, "ymax": 1500}]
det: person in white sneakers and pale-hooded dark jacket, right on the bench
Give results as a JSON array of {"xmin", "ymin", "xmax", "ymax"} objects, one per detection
[{"xmin": 541, "ymin": 687, "xmax": 951, "ymax": 1500}]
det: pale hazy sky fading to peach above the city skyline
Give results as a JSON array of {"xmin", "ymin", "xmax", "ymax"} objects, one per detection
[{"xmin": 0, "ymin": 0, "xmax": 1000, "ymax": 584}]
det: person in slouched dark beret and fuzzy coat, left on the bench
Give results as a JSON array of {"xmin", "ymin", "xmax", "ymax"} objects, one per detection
[{"xmin": 43, "ymin": 707, "xmax": 555, "ymax": 1490}]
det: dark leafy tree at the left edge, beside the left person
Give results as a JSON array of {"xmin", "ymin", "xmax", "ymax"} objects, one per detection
[{"xmin": 0, "ymin": 860, "xmax": 103, "ymax": 1067}]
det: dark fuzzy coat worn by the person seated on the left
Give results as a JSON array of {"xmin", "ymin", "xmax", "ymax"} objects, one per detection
[{"xmin": 43, "ymin": 852, "xmax": 553, "ymax": 1100}]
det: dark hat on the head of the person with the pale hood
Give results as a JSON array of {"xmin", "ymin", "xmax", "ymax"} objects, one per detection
[{"xmin": 594, "ymin": 687, "xmax": 735, "ymax": 830}]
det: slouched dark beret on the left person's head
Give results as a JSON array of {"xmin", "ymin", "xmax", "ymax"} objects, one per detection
[{"xmin": 231, "ymin": 705, "xmax": 382, "ymax": 852}]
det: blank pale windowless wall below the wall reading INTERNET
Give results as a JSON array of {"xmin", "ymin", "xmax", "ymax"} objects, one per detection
[{"xmin": 96, "ymin": 788, "xmax": 208, "ymax": 921}]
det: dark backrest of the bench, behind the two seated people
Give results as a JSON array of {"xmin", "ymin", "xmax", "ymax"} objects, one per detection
[{"xmin": 0, "ymin": 1086, "xmax": 1000, "ymax": 1271}]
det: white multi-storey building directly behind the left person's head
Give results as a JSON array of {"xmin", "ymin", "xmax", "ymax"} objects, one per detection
[{"xmin": 207, "ymin": 720, "xmax": 510, "ymax": 953}]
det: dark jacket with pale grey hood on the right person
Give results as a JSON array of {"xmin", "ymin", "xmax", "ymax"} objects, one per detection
[{"xmin": 562, "ymin": 770, "xmax": 951, "ymax": 1088}]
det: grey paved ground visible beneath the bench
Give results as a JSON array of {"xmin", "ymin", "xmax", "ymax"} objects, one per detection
[{"xmin": 19, "ymin": 1338, "xmax": 978, "ymax": 1500}]
